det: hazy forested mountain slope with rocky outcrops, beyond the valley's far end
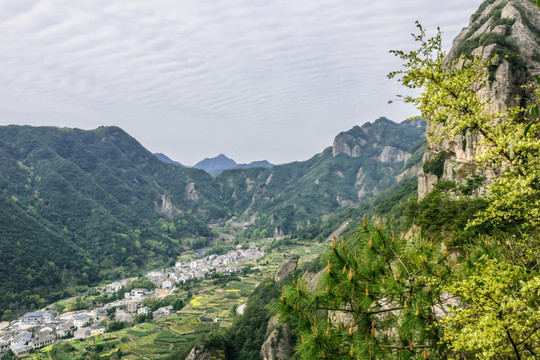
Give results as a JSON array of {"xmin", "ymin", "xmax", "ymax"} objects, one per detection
[{"xmin": 216, "ymin": 118, "xmax": 425, "ymax": 236}]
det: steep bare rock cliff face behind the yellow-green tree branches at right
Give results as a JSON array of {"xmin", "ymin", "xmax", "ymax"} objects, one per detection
[{"xmin": 418, "ymin": 0, "xmax": 540, "ymax": 199}]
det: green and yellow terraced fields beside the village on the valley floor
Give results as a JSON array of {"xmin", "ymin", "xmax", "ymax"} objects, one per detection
[{"xmin": 26, "ymin": 242, "xmax": 326, "ymax": 360}]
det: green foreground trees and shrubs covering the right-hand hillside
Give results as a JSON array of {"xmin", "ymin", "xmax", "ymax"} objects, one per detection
[{"xmin": 180, "ymin": 1, "xmax": 540, "ymax": 359}]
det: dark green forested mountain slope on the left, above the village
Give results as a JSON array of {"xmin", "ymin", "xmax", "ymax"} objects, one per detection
[{"xmin": 0, "ymin": 126, "xmax": 222, "ymax": 314}]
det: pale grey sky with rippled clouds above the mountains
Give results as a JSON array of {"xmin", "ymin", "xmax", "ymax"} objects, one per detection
[{"xmin": 0, "ymin": 0, "xmax": 482, "ymax": 165}]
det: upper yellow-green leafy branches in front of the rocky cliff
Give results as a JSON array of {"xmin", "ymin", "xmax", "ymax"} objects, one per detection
[{"xmin": 389, "ymin": 23, "xmax": 540, "ymax": 228}]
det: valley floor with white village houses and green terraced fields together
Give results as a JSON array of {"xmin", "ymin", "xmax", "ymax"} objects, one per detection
[{"xmin": 0, "ymin": 240, "xmax": 326, "ymax": 359}]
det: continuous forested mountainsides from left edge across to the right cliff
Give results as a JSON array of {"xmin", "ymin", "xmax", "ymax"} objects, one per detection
[{"xmin": 0, "ymin": 119, "xmax": 423, "ymax": 316}]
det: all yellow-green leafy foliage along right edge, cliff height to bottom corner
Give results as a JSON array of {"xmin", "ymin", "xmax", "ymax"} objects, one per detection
[{"xmin": 390, "ymin": 18, "xmax": 540, "ymax": 359}]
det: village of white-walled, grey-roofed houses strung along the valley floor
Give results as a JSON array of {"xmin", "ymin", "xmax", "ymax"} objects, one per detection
[{"xmin": 0, "ymin": 246, "xmax": 265, "ymax": 357}]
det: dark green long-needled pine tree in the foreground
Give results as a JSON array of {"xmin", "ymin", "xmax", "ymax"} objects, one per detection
[{"xmin": 279, "ymin": 224, "xmax": 464, "ymax": 359}]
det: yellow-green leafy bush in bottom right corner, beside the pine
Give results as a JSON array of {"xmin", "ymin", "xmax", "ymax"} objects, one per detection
[{"xmin": 442, "ymin": 259, "xmax": 540, "ymax": 359}]
